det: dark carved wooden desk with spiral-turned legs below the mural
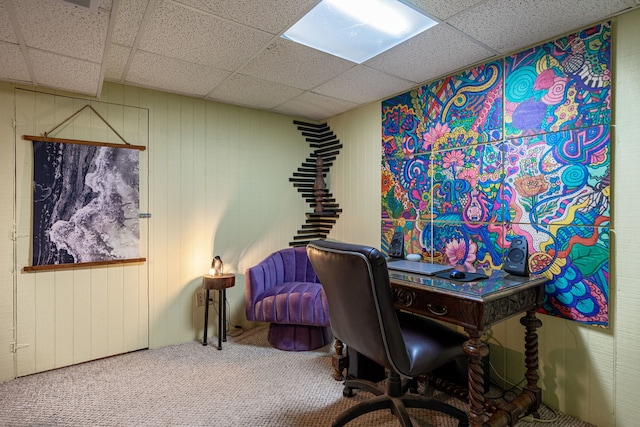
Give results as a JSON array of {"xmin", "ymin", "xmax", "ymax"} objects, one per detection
[{"xmin": 389, "ymin": 271, "xmax": 547, "ymax": 426}]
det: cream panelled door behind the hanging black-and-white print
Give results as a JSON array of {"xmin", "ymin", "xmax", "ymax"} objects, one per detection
[{"xmin": 15, "ymin": 88, "xmax": 149, "ymax": 376}]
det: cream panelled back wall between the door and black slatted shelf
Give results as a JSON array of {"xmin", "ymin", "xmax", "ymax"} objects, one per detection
[{"xmin": 96, "ymin": 84, "xmax": 310, "ymax": 347}]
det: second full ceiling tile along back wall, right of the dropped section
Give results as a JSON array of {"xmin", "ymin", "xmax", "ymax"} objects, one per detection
[{"xmin": 208, "ymin": 74, "xmax": 302, "ymax": 109}]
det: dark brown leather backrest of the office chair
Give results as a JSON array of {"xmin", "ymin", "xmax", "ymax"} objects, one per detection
[{"xmin": 307, "ymin": 240, "xmax": 409, "ymax": 372}]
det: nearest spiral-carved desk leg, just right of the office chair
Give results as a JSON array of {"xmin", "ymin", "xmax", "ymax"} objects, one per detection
[{"xmin": 463, "ymin": 330, "xmax": 489, "ymax": 427}]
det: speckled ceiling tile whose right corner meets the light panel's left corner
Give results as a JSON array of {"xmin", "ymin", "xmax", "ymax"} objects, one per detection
[{"xmin": 140, "ymin": 2, "xmax": 273, "ymax": 70}]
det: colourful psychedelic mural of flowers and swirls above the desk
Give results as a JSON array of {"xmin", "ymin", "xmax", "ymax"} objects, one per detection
[{"xmin": 381, "ymin": 22, "xmax": 611, "ymax": 327}]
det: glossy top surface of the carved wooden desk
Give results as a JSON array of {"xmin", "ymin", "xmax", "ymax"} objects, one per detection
[{"xmin": 389, "ymin": 270, "xmax": 548, "ymax": 301}]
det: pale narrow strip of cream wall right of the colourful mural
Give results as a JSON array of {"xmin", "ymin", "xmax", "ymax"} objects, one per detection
[{"xmin": 608, "ymin": 9, "xmax": 640, "ymax": 426}]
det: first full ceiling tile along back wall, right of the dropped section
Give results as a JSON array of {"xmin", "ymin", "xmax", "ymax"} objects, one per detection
[{"xmin": 126, "ymin": 50, "xmax": 230, "ymax": 97}]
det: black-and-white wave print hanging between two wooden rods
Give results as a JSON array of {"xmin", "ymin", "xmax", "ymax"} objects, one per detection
[{"xmin": 32, "ymin": 141, "xmax": 140, "ymax": 266}]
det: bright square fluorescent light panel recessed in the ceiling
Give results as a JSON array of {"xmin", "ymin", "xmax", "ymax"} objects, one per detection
[{"xmin": 282, "ymin": 0, "xmax": 437, "ymax": 64}]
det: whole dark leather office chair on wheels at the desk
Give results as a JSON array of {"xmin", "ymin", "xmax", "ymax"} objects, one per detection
[{"xmin": 307, "ymin": 240, "xmax": 468, "ymax": 427}]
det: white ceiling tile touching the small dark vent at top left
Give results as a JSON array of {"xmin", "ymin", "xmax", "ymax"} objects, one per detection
[{"xmin": 13, "ymin": 0, "xmax": 109, "ymax": 62}]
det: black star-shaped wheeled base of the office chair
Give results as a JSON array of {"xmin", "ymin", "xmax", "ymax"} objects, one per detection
[{"xmin": 332, "ymin": 378, "xmax": 469, "ymax": 427}]
